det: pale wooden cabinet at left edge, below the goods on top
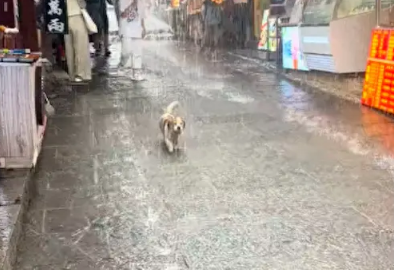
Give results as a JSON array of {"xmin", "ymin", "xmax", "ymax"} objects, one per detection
[{"xmin": 0, "ymin": 62, "xmax": 46, "ymax": 168}]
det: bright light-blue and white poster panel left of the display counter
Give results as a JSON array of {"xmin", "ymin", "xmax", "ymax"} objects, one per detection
[{"xmin": 282, "ymin": 26, "xmax": 309, "ymax": 71}]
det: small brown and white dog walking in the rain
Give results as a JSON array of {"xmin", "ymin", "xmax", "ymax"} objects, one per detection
[{"xmin": 159, "ymin": 101, "xmax": 186, "ymax": 153}]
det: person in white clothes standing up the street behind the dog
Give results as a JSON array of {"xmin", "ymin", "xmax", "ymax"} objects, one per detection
[{"xmin": 119, "ymin": 0, "xmax": 146, "ymax": 81}]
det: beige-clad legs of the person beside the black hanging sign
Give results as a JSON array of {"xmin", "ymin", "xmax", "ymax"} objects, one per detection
[{"xmin": 73, "ymin": 15, "xmax": 92, "ymax": 81}]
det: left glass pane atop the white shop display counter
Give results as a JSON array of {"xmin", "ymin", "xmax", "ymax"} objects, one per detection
[{"xmin": 303, "ymin": 0, "xmax": 336, "ymax": 25}]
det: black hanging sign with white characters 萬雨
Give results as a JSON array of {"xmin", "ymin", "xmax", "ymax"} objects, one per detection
[{"xmin": 44, "ymin": 0, "xmax": 68, "ymax": 35}]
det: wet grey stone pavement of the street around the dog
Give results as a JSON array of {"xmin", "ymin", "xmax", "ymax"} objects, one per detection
[{"xmin": 16, "ymin": 41, "xmax": 394, "ymax": 270}]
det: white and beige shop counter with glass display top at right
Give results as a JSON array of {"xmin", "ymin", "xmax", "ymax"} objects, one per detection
[{"xmin": 282, "ymin": 0, "xmax": 392, "ymax": 73}]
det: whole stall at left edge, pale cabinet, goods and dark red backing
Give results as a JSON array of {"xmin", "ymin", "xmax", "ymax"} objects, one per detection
[{"xmin": 0, "ymin": 0, "xmax": 46, "ymax": 169}]
